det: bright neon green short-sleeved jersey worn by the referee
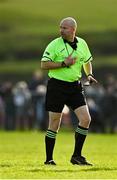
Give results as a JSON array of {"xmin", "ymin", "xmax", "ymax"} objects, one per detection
[{"xmin": 41, "ymin": 37, "xmax": 92, "ymax": 82}]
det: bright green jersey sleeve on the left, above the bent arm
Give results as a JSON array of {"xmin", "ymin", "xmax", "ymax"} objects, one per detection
[{"xmin": 41, "ymin": 41, "xmax": 55, "ymax": 61}]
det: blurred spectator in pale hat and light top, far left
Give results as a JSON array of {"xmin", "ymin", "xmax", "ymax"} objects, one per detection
[{"xmin": 13, "ymin": 81, "xmax": 32, "ymax": 130}]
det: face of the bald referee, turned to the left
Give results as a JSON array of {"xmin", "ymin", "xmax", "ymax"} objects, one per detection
[{"xmin": 60, "ymin": 22, "xmax": 74, "ymax": 40}]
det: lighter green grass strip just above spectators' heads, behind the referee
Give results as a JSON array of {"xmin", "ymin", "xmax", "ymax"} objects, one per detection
[{"xmin": 0, "ymin": 56, "xmax": 117, "ymax": 74}]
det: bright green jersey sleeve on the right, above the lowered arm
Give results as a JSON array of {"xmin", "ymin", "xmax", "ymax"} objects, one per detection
[{"xmin": 84, "ymin": 41, "xmax": 93, "ymax": 63}]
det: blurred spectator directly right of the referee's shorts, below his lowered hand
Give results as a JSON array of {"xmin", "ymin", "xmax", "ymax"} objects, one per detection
[{"xmin": 85, "ymin": 84, "xmax": 106, "ymax": 133}]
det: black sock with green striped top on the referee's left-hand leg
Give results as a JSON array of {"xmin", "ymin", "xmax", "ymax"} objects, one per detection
[{"xmin": 45, "ymin": 130, "xmax": 56, "ymax": 161}]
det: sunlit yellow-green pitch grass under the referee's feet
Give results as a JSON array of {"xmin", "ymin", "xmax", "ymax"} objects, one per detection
[{"xmin": 0, "ymin": 129, "xmax": 117, "ymax": 179}]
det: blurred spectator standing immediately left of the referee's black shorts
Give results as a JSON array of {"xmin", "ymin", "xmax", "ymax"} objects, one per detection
[{"xmin": 29, "ymin": 71, "xmax": 47, "ymax": 130}]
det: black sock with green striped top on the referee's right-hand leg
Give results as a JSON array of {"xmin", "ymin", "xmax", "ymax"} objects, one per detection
[{"xmin": 73, "ymin": 126, "xmax": 88, "ymax": 157}]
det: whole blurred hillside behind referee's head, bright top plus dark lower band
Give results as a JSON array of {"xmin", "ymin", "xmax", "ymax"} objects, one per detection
[{"xmin": 0, "ymin": 0, "xmax": 117, "ymax": 56}]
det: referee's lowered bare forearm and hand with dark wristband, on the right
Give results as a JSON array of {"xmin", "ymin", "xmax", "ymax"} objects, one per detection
[{"xmin": 83, "ymin": 61, "xmax": 97, "ymax": 83}]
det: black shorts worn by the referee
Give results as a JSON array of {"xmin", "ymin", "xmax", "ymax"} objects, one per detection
[{"xmin": 45, "ymin": 78, "xmax": 86, "ymax": 112}]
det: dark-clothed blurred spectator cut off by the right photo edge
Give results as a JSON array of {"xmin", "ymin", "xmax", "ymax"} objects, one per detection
[{"xmin": 102, "ymin": 74, "xmax": 117, "ymax": 133}]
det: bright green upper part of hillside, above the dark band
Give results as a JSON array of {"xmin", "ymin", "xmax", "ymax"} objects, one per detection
[{"xmin": 0, "ymin": 0, "xmax": 117, "ymax": 34}]
